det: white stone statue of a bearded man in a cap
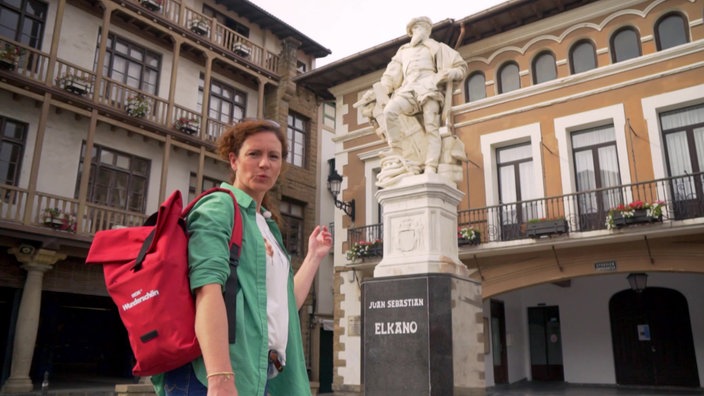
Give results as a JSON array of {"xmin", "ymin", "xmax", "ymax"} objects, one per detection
[{"xmin": 353, "ymin": 17, "xmax": 467, "ymax": 187}]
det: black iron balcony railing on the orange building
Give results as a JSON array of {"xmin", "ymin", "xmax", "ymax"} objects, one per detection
[{"xmin": 347, "ymin": 172, "xmax": 704, "ymax": 255}]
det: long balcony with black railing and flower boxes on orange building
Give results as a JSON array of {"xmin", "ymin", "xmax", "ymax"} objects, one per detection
[{"xmin": 347, "ymin": 172, "xmax": 704, "ymax": 259}]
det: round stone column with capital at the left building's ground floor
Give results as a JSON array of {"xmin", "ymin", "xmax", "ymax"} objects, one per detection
[{"xmin": 2, "ymin": 245, "xmax": 66, "ymax": 393}]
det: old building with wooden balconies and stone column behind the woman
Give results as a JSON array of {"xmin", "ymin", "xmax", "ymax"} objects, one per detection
[{"xmin": 0, "ymin": 0, "xmax": 332, "ymax": 394}]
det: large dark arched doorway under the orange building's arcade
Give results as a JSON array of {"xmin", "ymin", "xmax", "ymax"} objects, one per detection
[{"xmin": 609, "ymin": 287, "xmax": 699, "ymax": 387}]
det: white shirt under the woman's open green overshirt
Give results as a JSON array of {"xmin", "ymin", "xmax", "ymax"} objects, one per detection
[{"xmin": 257, "ymin": 213, "xmax": 290, "ymax": 364}]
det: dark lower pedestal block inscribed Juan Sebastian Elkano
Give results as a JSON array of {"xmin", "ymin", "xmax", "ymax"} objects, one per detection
[{"xmin": 362, "ymin": 274, "xmax": 486, "ymax": 396}]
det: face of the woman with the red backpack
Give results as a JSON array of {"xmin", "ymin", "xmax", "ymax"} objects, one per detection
[{"xmin": 230, "ymin": 131, "xmax": 283, "ymax": 204}]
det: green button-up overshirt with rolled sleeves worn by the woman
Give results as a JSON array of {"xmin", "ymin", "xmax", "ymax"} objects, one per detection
[{"xmin": 152, "ymin": 183, "xmax": 311, "ymax": 396}]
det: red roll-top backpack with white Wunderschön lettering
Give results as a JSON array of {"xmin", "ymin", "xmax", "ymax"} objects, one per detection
[{"xmin": 86, "ymin": 188, "xmax": 242, "ymax": 376}]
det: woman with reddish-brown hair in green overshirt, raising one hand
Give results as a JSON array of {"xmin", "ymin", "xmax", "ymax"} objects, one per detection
[{"xmin": 152, "ymin": 120, "xmax": 332, "ymax": 396}]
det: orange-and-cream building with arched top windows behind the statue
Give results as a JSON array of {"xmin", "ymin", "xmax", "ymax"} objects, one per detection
[{"xmin": 296, "ymin": 0, "xmax": 704, "ymax": 394}]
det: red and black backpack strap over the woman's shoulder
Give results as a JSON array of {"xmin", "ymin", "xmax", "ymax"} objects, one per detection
[{"xmin": 181, "ymin": 187, "xmax": 244, "ymax": 344}]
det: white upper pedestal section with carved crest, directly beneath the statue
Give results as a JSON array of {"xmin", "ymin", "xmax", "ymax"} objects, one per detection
[{"xmin": 374, "ymin": 174, "xmax": 468, "ymax": 277}]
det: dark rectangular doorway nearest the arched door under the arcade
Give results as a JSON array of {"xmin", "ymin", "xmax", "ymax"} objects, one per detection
[{"xmin": 528, "ymin": 306, "xmax": 565, "ymax": 381}]
